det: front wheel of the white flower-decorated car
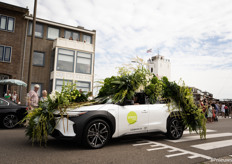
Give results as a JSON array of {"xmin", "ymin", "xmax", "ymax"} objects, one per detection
[{"xmin": 83, "ymin": 119, "xmax": 111, "ymax": 149}]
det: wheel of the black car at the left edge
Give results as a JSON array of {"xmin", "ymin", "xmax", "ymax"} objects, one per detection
[{"xmin": 2, "ymin": 113, "xmax": 19, "ymax": 129}]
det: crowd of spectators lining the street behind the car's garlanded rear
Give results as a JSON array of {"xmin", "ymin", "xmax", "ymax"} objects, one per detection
[{"xmin": 198, "ymin": 99, "xmax": 232, "ymax": 123}]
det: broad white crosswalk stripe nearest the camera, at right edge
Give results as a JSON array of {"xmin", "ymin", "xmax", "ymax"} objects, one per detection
[{"xmin": 191, "ymin": 140, "xmax": 232, "ymax": 150}]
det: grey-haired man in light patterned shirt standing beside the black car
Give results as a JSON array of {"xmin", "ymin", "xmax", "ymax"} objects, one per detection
[{"xmin": 28, "ymin": 84, "xmax": 39, "ymax": 110}]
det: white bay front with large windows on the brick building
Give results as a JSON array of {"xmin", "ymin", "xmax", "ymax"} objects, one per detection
[{"xmin": 50, "ymin": 38, "xmax": 95, "ymax": 91}]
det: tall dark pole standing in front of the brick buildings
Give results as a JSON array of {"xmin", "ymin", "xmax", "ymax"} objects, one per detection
[{"xmin": 27, "ymin": 0, "xmax": 37, "ymax": 92}]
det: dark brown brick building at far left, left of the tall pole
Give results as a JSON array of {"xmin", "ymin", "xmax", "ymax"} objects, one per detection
[{"xmin": 0, "ymin": 2, "xmax": 29, "ymax": 96}]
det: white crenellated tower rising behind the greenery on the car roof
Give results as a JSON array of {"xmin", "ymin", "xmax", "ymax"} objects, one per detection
[{"xmin": 147, "ymin": 55, "xmax": 171, "ymax": 80}]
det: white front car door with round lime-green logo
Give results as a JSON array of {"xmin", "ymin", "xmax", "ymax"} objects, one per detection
[{"xmin": 118, "ymin": 104, "xmax": 148, "ymax": 136}]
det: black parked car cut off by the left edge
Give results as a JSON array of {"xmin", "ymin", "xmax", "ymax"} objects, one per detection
[{"xmin": 0, "ymin": 98, "xmax": 27, "ymax": 129}]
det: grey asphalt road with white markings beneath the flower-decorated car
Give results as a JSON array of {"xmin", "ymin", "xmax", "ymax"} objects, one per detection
[{"xmin": 0, "ymin": 118, "xmax": 232, "ymax": 164}]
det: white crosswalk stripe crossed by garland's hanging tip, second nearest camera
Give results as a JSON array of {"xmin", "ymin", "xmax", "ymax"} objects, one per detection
[{"xmin": 167, "ymin": 133, "xmax": 232, "ymax": 143}]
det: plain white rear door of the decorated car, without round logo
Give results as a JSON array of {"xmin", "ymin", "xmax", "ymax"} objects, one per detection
[{"xmin": 148, "ymin": 104, "xmax": 169, "ymax": 132}]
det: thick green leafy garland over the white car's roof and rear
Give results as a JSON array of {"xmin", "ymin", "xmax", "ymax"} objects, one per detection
[{"xmin": 98, "ymin": 57, "xmax": 206, "ymax": 138}]
